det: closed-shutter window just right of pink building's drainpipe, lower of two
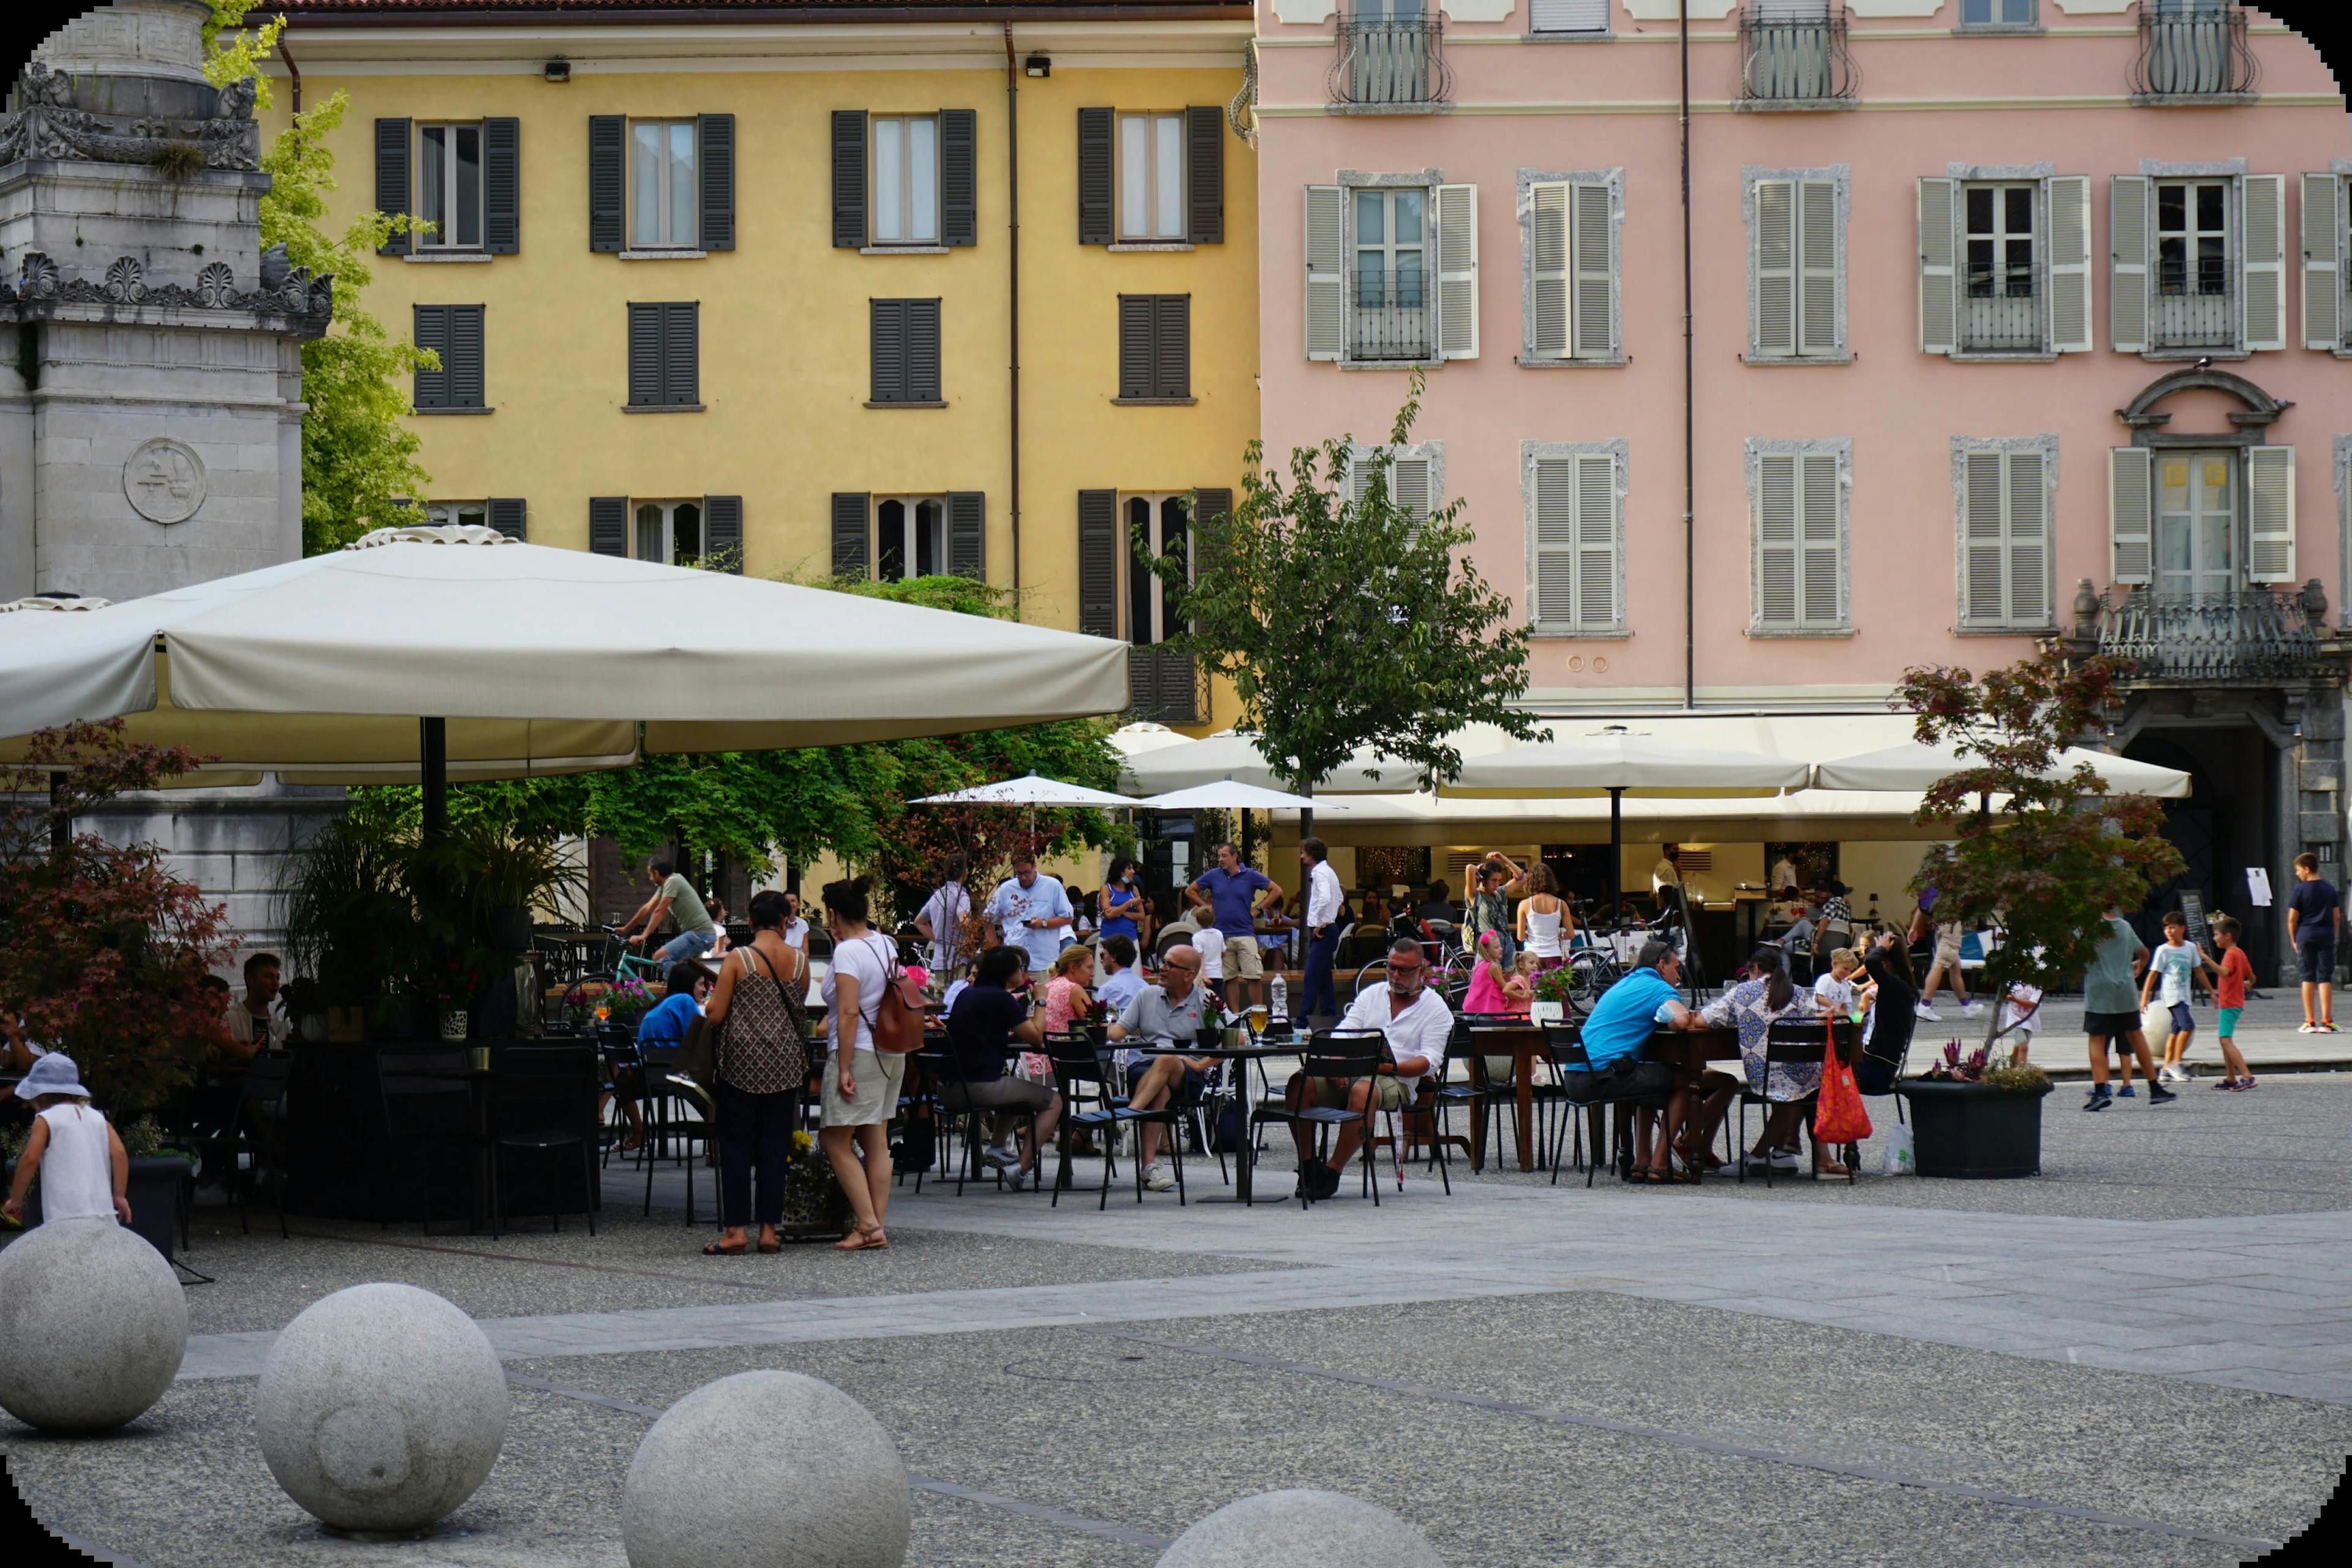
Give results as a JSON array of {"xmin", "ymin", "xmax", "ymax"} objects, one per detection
[{"xmin": 1747, "ymin": 437, "xmax": 1853, "ymax": 637}]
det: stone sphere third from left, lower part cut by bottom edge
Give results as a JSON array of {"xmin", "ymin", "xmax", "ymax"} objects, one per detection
[{"xmin": 621, "ymin": 1371, "xmax": 910, "ymax": 1568}]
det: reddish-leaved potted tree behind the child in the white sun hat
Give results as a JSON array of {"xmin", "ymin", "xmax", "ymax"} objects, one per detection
[{"xmin": 0, "ymin": 719, "xmax": 228, "ymax": 1257}]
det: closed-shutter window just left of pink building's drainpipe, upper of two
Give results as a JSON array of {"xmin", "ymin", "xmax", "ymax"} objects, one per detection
[{"xmin": 1520, "ymin": 169, "xmax": 1625, "ymax": 364}]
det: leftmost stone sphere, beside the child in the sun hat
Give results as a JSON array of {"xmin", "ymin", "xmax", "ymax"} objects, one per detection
[{"xmin": 0, "ymin": 1215, "xmax": 188, "ymax": 1431}]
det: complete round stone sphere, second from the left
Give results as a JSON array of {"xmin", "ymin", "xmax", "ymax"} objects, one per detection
[{"xmin": 254, "ymin": 1284, "xmax": 508, "ymax": 1532}]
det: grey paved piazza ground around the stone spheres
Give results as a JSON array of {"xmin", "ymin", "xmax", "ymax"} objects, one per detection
[{"xmin": 0, "ymin": 1062, "xmax": 2352, "ymax": 1568}]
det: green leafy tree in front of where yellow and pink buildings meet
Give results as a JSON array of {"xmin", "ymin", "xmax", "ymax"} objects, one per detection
[{"xmin": 1136, "ymin": 371, "xmax": 1536, "ymax": 827}]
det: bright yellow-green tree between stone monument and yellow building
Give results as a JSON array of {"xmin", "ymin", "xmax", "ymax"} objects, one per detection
[{"xmin": 205, "ymin": 0, "xmax": 440, "ymax": 555}]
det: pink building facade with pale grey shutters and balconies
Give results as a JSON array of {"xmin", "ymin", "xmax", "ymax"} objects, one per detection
[{"xmin": 1254, "ymin": 0, "xmax": 2352, "ymax": 973}]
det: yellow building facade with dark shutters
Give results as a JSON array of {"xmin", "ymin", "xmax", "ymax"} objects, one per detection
[{"xmin": 266, "ymin": 0, "xmax": 1258, "ymax": 729}]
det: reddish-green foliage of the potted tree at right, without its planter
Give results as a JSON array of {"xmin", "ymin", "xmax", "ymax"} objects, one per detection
[{"xmin": 1896, "ymin": 649, "xmax": 2183, "ymax": 1049}]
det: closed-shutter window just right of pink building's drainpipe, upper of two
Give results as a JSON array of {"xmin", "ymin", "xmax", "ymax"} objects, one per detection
[{"xmin": 1743, "ymin": 165, "xmax": 1851, "ymax": 364}]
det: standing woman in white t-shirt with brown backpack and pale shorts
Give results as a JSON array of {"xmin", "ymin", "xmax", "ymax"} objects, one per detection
[{"xmin": 816, "ymin": 877, "xmax": 905, "ymax": 1253}]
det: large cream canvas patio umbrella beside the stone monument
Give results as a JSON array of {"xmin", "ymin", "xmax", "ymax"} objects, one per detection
[{"xmin": 0, "ymin": 529, "xmax": 1129, "ymax": 813}]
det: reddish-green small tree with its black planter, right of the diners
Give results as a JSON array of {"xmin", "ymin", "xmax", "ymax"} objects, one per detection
[{"xmin": 1896, "ymin": 649, "xmax": 2180, "ymax": 1178}]
